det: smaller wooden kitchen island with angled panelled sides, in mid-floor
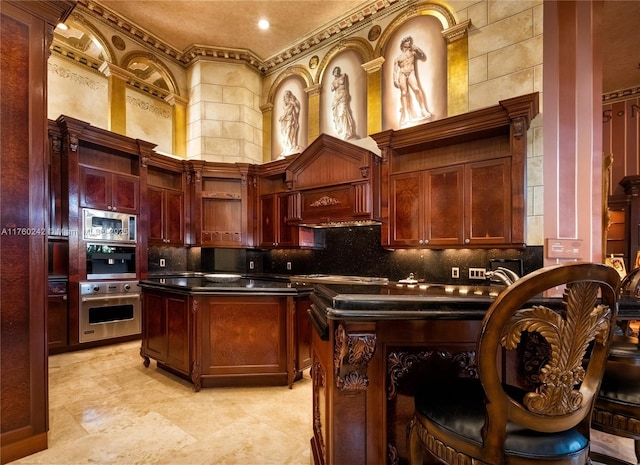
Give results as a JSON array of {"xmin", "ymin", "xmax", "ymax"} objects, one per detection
[{"xmin": 139, "ymin": 274, "xmax": 312, "ymax": 391}]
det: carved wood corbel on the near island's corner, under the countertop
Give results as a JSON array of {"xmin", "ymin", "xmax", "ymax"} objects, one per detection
[{"xmin": 333, "ymin": 322, "xmax": 376, "ymax": 393}]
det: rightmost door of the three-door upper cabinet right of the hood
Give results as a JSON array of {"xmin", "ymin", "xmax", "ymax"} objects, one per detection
[{"xmin": 464, "ymin": 158, "xmax": 511, "ymax": 244}]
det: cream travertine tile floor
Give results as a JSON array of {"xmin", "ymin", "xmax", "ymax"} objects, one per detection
[{"xmin": 12, "ymin": 341, "xmax": 635, "ymax": 465}]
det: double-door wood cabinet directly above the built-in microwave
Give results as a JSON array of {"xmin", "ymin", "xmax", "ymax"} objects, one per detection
[{"xmin": 80, "ymin": 166, "xmax": 140, "ymax": 213}]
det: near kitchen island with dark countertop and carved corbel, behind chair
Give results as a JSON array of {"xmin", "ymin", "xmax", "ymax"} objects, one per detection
[{"xmin": 310, "ymin": 283, "xmax": 640, "ymax": 465}]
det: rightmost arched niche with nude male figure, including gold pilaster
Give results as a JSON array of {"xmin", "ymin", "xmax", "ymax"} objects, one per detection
[{"xmin": 376, "ymin": 2, "xmax": 470, "ymax": 129}]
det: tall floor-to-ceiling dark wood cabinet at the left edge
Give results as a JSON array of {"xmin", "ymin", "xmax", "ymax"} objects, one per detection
[{"xmin": 0, "ymin": 0, "xmax": 75, "ymax": 463}]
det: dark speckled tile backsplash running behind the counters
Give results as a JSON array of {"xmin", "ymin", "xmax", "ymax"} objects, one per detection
[{"xmin": 149, "ymin": 226, "xmax": 543, "ymax": 284}]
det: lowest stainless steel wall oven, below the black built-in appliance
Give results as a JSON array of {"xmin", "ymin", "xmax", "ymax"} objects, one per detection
[{"xmin": 79, "ymin": 281, "xmax": 141, "ymax": 342}]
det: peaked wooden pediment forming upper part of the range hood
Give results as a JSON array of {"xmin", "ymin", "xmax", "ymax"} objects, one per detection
[{"xmin": 285, "ymin": 134, "xmax": 380, "ymax": 191}]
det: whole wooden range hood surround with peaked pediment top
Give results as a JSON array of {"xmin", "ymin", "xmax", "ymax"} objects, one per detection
[{"xmin": 285, "ymin": 134, "xmax": 381, "ymax": 227}]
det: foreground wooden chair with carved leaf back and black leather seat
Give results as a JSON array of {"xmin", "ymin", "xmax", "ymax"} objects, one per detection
[{"xmin": 409, "ymin": 262, "xmax": 620, "ymax": 465}]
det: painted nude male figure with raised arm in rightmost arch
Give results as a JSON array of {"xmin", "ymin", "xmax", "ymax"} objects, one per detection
[{"xmin": 393, "ymin": 36, "xmax": 432, "ymax": 127}]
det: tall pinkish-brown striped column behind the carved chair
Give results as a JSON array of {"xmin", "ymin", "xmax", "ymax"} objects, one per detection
[{"xmin": 543, "ymin": 0, "xmax": 603, "ymax": 265}]
